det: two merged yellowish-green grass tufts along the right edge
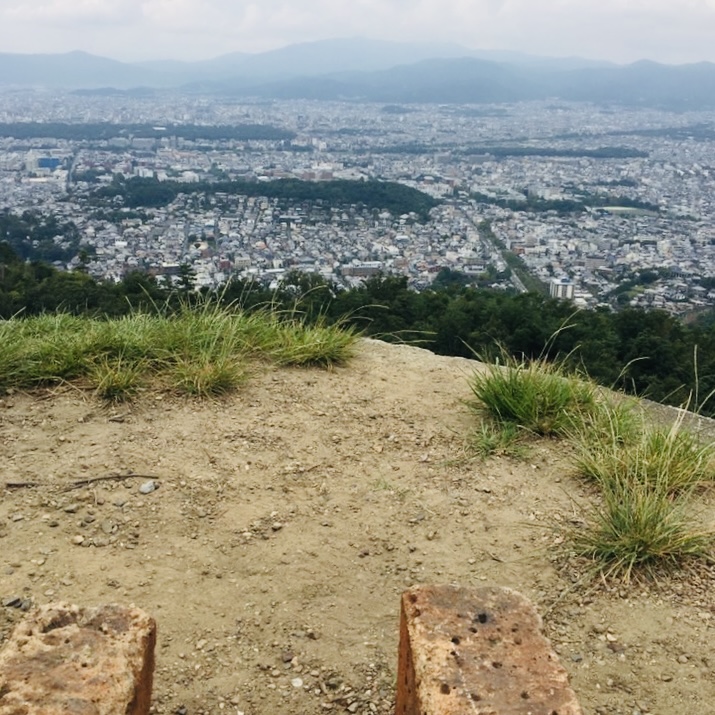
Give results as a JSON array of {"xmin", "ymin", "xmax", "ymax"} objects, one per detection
[{"xmin": 573, "ymin": 406, "xmax": 715, "ymax": 581}]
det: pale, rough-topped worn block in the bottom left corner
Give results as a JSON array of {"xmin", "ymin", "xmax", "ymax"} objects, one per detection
[{"xmin": 0, "ymin": 603, "xmax": 156, "ymax": 715}]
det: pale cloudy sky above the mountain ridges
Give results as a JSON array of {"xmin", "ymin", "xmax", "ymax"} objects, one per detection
[{"xmin": 0, "ymin": 0, "xmax": 715, "ymax": 63}]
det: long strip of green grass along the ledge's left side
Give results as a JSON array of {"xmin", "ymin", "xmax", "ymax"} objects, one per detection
[{"xmin": 0, "ymin": 300, "xmax": 357, "ymax": 402}]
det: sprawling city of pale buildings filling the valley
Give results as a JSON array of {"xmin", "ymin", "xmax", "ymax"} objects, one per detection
[{"xmin": 0, "ymin": 90, "xmax": 715, "ymax": 314}]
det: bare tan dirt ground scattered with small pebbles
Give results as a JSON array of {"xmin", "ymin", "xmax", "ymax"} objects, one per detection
[{"xmin": 0, "ymin": 340, "xmax": 715, "ymax": 715}]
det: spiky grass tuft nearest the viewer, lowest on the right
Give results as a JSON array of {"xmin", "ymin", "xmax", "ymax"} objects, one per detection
[{"xmin": 573, "ymin": 477, "xmax": 715, "ymax": 581}]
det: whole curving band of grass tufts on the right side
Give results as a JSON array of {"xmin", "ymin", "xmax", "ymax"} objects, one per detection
[{"xmin": 470, "ymin": 344, "xmax": 715, "ymax": 581}]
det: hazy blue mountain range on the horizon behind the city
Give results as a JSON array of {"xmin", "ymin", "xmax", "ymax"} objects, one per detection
[{"xmin": 0, "ymin": 38, "xmax": 715, "ymax": 109}]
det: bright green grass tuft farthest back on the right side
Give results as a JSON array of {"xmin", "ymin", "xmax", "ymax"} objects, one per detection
[{"xmin": 470, "ymin": 356, "xmax": 596, "ymax": 435}]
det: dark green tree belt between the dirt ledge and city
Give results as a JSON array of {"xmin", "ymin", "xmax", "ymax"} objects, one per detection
[{"xmin": 0, "ymin": 252, "xmax": 715, "ymax": 416}]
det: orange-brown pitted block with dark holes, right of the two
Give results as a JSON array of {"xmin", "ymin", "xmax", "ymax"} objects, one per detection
[{"xmin": 396, "ymin": 586, "xmax": 583, "ymax": 715}]
